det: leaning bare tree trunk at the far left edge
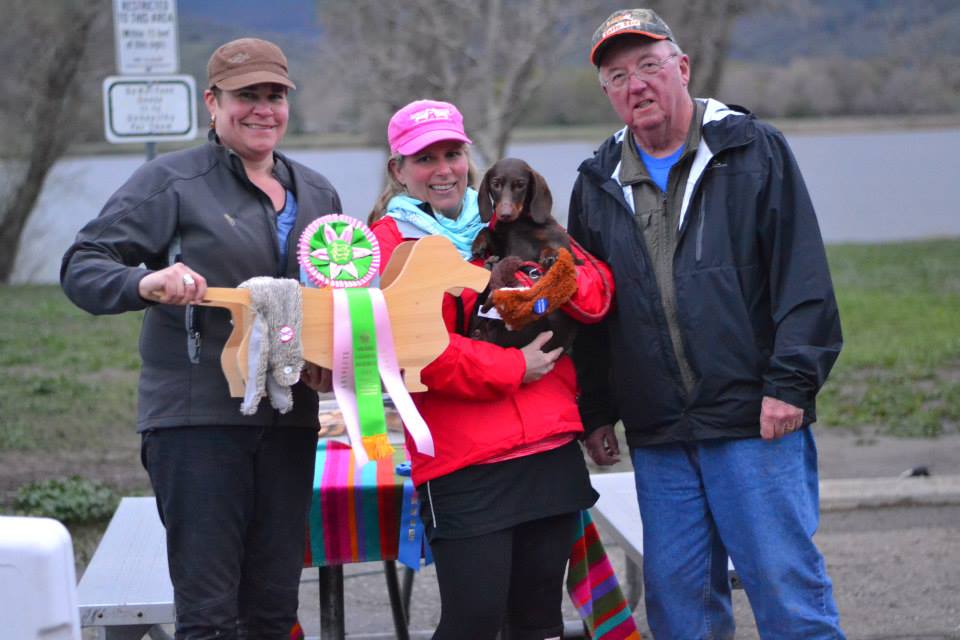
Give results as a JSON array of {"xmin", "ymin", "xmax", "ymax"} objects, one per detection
[{"xmin": 0, "ymin": 0, "xmax": 106, "ymax": 283}]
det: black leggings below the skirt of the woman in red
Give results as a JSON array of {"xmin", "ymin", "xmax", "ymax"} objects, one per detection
[{"xmin": 430, "ymin": 513, "xmax": 578, "ymax": 640}]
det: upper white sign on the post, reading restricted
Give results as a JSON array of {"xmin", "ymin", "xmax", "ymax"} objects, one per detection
[{"xmin": 113, "ymin": 0, "xmax": 180, "ymax": 74}]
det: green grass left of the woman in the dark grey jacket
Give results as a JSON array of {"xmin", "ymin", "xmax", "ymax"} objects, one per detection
[{"xmin": 0, "ymin": 286, "xmax": 141, "ymax": 451}]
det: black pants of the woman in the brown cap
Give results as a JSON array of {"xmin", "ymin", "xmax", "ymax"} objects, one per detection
[{"xmin": 141, "ymin": 427, "xmax": 317, "ymax": 640}]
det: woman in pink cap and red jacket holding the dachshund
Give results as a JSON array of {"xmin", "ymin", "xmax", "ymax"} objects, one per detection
[{"xmin": 370, "ymin": 100, "xmax": 597, "ymax": 640}]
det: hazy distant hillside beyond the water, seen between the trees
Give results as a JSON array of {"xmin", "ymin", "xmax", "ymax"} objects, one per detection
[{"xmin": 114, "ymin": 0, "xmax": 960, "ymax": 138}]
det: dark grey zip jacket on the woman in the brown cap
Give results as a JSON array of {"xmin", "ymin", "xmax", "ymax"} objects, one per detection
[{"xmin": 60, "ymin": 139, "xmax": 341, "ymax": 431}]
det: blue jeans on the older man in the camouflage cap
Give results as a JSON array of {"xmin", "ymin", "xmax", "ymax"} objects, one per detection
[{"xmin": 631, "ymin": 427, "xmax": 844, "ymax": 640}]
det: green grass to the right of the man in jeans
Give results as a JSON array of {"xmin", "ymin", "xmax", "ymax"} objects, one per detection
[{"xmin": 818, "ymin": 240, "xmax": 960, "ymax": 436}]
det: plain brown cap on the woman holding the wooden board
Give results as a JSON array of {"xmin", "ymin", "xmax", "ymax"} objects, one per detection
[{"xmin": 207, "ymin": 38, "xmax": 297, "ymax": 91}]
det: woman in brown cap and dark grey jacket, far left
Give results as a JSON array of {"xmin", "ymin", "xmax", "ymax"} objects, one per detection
[{"xmin": 61, "ymin": 38, "xmax": 341, "ymax": 640}]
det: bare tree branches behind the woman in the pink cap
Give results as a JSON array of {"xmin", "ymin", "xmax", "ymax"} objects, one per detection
[{"xmin": 319, "ymin": 0, "xmax": 598, "ymax": 168}]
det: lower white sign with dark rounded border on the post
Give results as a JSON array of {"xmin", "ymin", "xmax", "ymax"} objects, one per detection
[{"xmin": 103, "ymin": 75, "xmax": 197, "ymax": 143}]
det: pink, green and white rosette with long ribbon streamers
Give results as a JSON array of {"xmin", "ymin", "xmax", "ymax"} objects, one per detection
[{"xmin": 299, "ymin": 215, "xmax": 434, "ymax": 466}]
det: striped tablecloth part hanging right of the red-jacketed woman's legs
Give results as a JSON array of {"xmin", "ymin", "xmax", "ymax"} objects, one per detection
[{"xmin": 567, "ymin": 511, "xmax": 642, "ymax": 640}]
